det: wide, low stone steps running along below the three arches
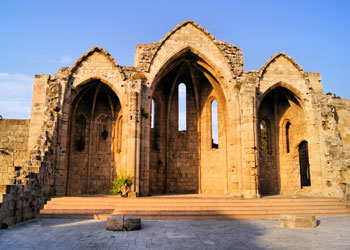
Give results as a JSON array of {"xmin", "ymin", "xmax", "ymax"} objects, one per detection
[{"xmin": 40, "ymin": 195, "xmax": 350, "ymax": 220}]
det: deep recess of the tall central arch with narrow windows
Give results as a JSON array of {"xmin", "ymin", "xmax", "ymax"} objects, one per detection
[{"xmin": 149, "ymin": 51, "xmax": 227, "ymax": 194}]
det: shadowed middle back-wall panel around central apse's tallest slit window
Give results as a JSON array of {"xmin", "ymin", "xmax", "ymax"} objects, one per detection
[{"xmin": 166, "ymin": 75, "xmax": 199, "ymax": 193}]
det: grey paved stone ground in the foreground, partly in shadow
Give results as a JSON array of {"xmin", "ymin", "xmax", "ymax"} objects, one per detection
[{"xmin": 0, "ymin": 215, "xmax": 350, "ymax": 250}]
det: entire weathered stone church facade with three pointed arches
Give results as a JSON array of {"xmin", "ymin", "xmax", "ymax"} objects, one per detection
[{"xmin": 1, "ymin": 21, "xmax": 350, "ymax": 227}]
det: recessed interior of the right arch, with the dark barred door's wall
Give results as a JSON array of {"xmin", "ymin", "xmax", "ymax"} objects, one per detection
[{"xmin": 258, "ymin": 86, "xmax": 307, "ymax": 195}]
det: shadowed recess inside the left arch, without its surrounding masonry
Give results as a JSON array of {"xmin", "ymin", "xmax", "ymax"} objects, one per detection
[{"xmin": 66, "ymin": 80, "xmax": 122, "ymax": 195}]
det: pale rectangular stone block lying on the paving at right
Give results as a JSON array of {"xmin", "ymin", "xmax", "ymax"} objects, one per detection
[{"xmin": 279, "ymin": 214, "xmax": 317, "ymax": 228}]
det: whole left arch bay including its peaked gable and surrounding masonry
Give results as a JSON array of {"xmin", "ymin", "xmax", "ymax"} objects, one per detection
[{"xmin": 55, "ymin": 47, "xmax": 131, "ymax": 195}]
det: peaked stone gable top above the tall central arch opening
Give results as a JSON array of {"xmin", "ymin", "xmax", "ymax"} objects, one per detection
[{"xmin": 142, "ymin": 21, "xmax": 243, "ymax": 89}]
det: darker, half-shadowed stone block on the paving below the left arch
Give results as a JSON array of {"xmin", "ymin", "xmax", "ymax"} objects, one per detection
[{"xmin": 106, "ymin": 215, "xmax": 141, "ymax": 231}]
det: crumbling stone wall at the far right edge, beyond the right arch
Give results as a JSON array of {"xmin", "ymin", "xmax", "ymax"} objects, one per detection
[{"xmin": 321, "ymin": 94, "xmax": 350, "ymax": 206}]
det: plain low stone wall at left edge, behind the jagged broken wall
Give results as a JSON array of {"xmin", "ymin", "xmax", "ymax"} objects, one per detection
[{"xmin": 0, "ymin": 119, "xmax": 30, "ymax": 188}]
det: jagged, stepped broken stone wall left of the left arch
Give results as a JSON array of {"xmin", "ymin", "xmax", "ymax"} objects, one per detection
[{"xmin": 0, "ymin": 73, "xmax": 60, "ymax": 228}]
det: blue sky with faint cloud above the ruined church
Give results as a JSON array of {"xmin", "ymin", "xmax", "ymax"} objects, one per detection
[{"xmin": 0, "ymin": 0, "xmax": 350, "ymax": 118}]
